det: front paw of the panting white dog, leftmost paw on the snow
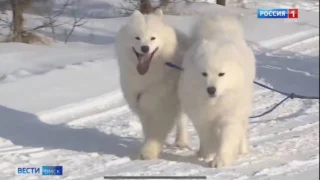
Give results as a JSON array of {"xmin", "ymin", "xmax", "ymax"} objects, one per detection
[{"xmin": 139, "ymin": 141, "xmax": 162, "ymax": 160}]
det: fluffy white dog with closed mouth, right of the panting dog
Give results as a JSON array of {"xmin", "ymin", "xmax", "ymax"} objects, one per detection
[{"xmin": 178, "ymin": 17, "xmax": 256, "ymax": 168}]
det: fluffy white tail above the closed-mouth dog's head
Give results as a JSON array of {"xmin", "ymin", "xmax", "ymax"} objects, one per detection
[{"xmin": 191, "ymin": 16, "xmax": 244, "ymax": 42}]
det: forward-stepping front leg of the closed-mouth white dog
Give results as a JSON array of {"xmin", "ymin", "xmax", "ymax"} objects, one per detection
[{"xmin": 211, "ymin": 123, "xmax": 244, "ymax": 168}]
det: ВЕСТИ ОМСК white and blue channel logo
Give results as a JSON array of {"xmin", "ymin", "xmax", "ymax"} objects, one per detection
[{"xmin": 16, "ymin": 166, "xmax": 63, "ymax": 176}]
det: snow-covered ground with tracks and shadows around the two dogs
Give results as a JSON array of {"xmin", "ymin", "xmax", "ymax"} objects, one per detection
[{"xmin": 0, "ymin": 0, "xmax": 319, "ymax": 180}]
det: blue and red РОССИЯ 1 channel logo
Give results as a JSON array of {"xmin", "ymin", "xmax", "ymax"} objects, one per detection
[{"xmin": 257, "ymin": 9, "xmax": 299, "ymax": 19}]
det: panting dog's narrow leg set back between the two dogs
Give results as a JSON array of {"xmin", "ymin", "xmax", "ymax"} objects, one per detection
[{"xmin": 175, "ymin": 113, "xmax": 192, "ymax": 150}]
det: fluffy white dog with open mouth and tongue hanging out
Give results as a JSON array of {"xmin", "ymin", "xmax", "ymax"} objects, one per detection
[{"xmin": 116, "ymin": 10, "xmax": 188, "ymax": 160}]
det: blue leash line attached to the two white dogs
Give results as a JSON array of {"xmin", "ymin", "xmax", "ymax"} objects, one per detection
[{"xmin": 165, "ymin": 62, "xmax": 319, "ymax": 119}]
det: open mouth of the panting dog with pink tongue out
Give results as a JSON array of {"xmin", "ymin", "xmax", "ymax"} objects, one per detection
[{"xmin": 132, "ymin": 47, "xmax": 158, "ymax": 75}]
